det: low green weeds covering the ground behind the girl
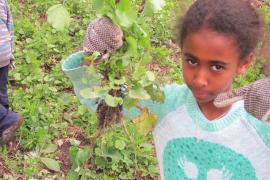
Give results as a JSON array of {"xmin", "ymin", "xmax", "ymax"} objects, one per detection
[{"xmin": 0, "ymin": 0, "xmax": 270, "ymax": 179}]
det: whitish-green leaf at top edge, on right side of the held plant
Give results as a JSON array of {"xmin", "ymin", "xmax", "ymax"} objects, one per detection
[{"xmin": 143, "ymin": 0, "xmax": 166, "ymax": 16}]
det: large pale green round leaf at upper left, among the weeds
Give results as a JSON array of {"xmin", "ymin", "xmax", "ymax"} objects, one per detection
[{"xmin": 47, "ymin": 4, "xmax": 70, "ymax": 31}]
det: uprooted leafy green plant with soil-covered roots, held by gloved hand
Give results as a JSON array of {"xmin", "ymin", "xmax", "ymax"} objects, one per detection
[{"xmin": 76, "ymin": 0, "xmax": 168, "ymax": 127}]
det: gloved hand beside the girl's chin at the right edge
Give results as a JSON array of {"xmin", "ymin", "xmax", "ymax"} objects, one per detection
[{"xmin": 214, "ymin": 77, "xmax": 270, "ymax": 122}]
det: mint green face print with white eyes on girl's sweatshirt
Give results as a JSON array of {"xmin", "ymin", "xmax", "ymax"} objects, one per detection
[{"xmin": 163, "ymin": 138, "xmax": 257, "ymax": 180}]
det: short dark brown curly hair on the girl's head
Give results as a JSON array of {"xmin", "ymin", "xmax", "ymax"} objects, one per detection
[{"xmin": 177, "ymin": 0, "xmax": 263, "ymax": 60}]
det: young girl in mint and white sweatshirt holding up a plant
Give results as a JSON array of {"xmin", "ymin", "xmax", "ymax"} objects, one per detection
[{"xmin": 63, "ymin": 0, "xmax": 270, "ymax": 180}]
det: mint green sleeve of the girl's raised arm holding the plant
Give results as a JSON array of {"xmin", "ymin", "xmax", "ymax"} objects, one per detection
[{"xmin": 62, "ymin": 52, "xmax": 187, "ymax": 120}]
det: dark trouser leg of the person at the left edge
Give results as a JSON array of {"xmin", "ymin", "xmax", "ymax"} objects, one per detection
[{"xmin": 0, "ymin": 66, "xmax": 18, "ymax": 135}]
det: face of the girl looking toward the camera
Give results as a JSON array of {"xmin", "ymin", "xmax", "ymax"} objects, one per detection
[{"xmin": 182, "ymin": 29, "xmax": 252, "ymax": 103}]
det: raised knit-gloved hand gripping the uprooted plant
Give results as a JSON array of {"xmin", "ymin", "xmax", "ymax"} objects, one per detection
[{"xmin": 83, "ymin": 17, "xmax": 123, "ymax": 61}]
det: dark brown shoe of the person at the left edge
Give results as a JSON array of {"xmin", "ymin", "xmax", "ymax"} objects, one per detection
[{"xmin": 0, "ymin": 116, "xmax": 24, "ymax": 144}]
